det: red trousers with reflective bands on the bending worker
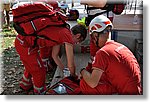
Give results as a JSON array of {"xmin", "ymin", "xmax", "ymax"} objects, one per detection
[{"xmin": 15, "ymin": 38, "xmax": 46, "ymax": 94}]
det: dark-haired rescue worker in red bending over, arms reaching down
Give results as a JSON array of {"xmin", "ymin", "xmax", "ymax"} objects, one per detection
[{"xmin": 15, "ymin": 25, "xmax": 87, "ymax": 94}]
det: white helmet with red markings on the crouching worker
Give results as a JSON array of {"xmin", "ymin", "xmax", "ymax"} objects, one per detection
[{"xmin": 89, "ymin": 15, "xmax": 113, "ymax": 35}]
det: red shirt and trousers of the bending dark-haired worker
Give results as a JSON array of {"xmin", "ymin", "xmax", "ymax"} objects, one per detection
[{"xmin": 15, "ymin": 27, "xmax": 73, "ymax": 94}]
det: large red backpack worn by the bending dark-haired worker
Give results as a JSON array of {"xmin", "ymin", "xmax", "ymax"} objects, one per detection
[{"xmin": 12, "ymin": 2, "xmax": 68, "ymax": 45}]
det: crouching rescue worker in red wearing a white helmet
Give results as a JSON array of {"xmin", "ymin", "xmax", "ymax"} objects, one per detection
[{"xmin": 80, "ymin": 15, "xmax": 142, "ymax": 95}]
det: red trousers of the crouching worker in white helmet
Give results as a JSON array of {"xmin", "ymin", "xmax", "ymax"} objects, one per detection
[{"xmin": 80, "ymin": 79, "xmax": 115, "ymax": 95}]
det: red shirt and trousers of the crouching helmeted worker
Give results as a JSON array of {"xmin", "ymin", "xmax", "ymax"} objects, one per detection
[{"xmin": 80, "ymin": 41, "xmax": 142, "ymax": 94}]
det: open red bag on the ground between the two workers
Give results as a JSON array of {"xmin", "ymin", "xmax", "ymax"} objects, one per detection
[{"xmin": 46, "ymin": 76, "xmax": 82, "ymax": 95}]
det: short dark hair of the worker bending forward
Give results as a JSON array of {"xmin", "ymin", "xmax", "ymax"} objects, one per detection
[{"xmin": 71, "ymin": 24, "xmax": 87, "ymax": 40}]
